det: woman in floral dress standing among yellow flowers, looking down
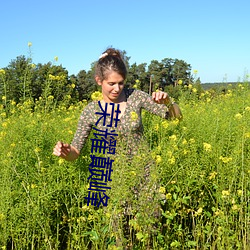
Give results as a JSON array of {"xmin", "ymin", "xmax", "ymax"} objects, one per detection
[{"xmin": 53, "ymin": 48, "xmax": 182, "ymax": 245}]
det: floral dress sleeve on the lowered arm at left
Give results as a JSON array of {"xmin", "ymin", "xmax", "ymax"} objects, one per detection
[{"xmin": 71, "ymin": 102, "xmax": 95, "ymax": 152}]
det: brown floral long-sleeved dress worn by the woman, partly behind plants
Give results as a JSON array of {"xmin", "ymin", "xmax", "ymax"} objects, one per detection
[{"xmin": 72, "ymin": 88, "xmax": 169, "ymax": 240}]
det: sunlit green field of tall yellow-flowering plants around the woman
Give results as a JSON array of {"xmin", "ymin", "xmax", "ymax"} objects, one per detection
[{"xmin": 0, "ymin": 83, "xmax": 250, "ymax": 250}]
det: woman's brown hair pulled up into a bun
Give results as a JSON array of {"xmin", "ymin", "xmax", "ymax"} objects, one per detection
[{"xmin": 95, "ymin": 48, "xmax": 127, "ymax": 81}]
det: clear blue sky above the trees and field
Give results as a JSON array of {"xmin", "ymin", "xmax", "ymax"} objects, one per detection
[{"xmin": 0, "ymin": 0, "xmax": 250, "ymax": 83}]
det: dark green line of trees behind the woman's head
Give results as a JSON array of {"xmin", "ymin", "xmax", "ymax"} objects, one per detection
[{"xmin": 0, "ymin": 51, "xmax": 199, "ymax": 103}]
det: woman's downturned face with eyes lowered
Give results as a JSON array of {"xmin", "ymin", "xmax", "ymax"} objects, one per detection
[{"xmin": 96, "ymin": 71, "xmax": 124, "ymax": 103}]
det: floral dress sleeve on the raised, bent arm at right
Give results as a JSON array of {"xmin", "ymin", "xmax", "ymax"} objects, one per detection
[{"xmin": 136, "ymin": 90, "xmax": 169, "ymax": 119}]
